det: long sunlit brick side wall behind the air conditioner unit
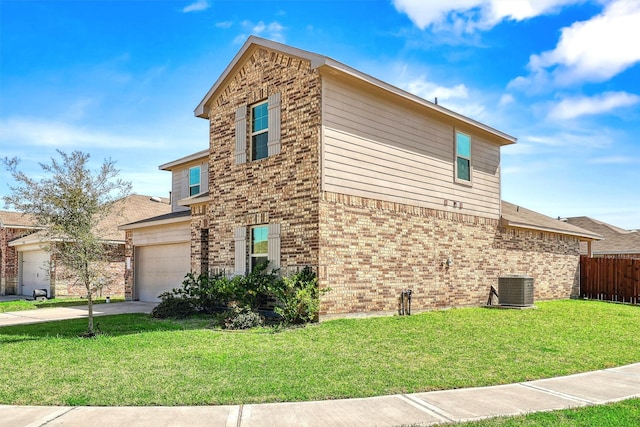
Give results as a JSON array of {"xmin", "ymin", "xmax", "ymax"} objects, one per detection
[{"xmin": 319, "ymin": 193, "xmax": 579, "ymax": 319}]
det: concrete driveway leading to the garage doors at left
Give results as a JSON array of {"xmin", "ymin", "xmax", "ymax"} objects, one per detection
[{"xmin": 0, "ymin": 301, "xmax": 157, "ymax": 327}]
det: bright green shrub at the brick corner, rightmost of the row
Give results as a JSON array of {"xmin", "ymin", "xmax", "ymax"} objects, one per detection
[{"xmin": 271, "ymin": 267, "xmax": 327, "ymax": 324}]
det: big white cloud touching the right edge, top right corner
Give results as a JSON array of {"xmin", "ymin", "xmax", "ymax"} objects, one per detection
[{"xmin": 509, "ymin": 0, "xmax": 640, "ymax": 90}]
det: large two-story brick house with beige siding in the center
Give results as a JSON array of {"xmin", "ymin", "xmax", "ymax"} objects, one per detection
[{"xmin": 124, "ymin": 37, "xmax": 599, "ymax": 319}]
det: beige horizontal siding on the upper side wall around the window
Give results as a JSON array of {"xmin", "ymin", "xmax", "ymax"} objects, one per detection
[{"xmin": 322, "ymin": 76, "xmax": 500, "ymax": 218}]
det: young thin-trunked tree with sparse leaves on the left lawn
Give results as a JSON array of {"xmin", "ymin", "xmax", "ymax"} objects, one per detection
[{"xmin": 3, "ymin": 150, "xmax": 131, "ymax": 336}]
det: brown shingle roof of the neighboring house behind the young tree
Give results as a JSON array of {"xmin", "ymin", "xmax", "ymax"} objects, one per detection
[{"xmin": 9, "ymin": 194, "xmax": 171, "ymax": 246}]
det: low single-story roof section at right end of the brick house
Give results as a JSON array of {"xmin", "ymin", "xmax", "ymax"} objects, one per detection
[{"xmin": 500, "ymin": 200, "xmax": 602, "ymax": 241}]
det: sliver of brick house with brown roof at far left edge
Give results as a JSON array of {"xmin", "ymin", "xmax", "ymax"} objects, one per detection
[{"xmin": 0, "ymin": 211, "xmax": 38, "ymax": 295}]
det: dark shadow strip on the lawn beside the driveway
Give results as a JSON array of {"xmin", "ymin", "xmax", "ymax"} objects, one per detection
[{"xmin": 0, "ymin": 313, "xmax": 212, "ymax": 343}]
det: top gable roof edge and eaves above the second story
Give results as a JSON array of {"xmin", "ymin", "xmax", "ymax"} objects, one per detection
[{"xmin": 194, "ymin": 36, "xmax": 517, "ymax": 145}]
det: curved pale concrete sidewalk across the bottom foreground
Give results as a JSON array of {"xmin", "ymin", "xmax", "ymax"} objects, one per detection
[{"xmin": 0, "ymin": 363, "xmax": 640, "ymax": 427}]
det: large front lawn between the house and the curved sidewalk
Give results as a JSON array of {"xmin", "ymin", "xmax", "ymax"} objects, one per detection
[{"xmin": 0, "ymin": 300, "xmax": 640, "ymax": 405}]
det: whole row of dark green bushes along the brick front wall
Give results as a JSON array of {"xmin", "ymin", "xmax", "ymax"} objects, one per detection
[{"xmin": 151, "ymin": 263, "xmax": 320, "ymax": 329}]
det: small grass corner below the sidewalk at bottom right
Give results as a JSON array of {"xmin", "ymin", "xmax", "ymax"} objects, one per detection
[{"xmin": 458, "ymin": 399, "xmax": 640, "ymax": 427}]
